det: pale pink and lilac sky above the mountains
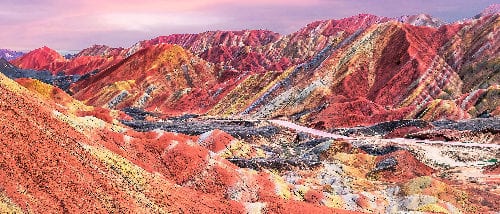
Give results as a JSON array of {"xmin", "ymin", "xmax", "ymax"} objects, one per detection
[{"xmin": 0, "ymin": 0, "xmax": 497, "ymax": 51}]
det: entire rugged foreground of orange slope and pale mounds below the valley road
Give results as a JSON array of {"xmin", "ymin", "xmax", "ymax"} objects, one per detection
[{"xmin": 0, "ymin": 70, "xmax": 500, "ymax": 213}]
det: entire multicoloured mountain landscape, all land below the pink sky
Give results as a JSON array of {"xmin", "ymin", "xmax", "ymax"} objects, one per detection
[{"xmin": 0, "ymin": 5, "xmax": 500, "ymax": 213}]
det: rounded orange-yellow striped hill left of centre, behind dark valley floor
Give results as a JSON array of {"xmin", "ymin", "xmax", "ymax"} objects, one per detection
[{"xmin": 71, "ymin": 44, "xmax": 227, "ymax": 114}]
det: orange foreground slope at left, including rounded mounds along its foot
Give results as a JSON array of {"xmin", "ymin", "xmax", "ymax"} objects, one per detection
[{"xmin": 0, "ymin": 74, "xmax": 358, "ymax": 213}]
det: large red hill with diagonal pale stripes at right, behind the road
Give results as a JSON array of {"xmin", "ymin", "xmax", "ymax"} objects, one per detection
[{"xmin": 209, "ymin": 14, "xmax": 500, "ymax": 128}]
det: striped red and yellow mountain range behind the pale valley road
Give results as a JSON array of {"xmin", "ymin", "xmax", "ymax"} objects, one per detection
[{"xmin": 11, "ymin": 9, "xmax": 500, "ymax": 129}]
